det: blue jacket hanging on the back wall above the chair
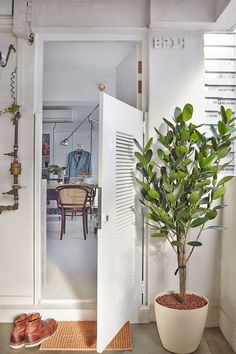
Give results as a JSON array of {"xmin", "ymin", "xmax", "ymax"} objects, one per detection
[{"xmin": 67, "ymin": 150, "xmax": 92, "ymax": 178}]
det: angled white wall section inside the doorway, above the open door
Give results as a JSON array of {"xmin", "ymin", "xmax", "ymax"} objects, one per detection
[{"xmin": 116, "ymin": 49, "xmax": 138, "ymax": 107}]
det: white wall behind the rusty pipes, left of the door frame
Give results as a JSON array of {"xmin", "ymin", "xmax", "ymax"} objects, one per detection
[{"xmin": 0, "ymin": 33, "xmax": 33, "ymax": 304}]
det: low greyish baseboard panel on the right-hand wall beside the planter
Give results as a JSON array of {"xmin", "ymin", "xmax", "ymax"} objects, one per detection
[{"xmin": 219, "ymin": 308, "xmax": 236, "ymax": 352}]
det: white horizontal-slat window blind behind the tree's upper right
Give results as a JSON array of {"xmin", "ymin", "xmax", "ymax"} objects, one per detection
[{"xmin": 204, "ymin": 32, "xmax": 236, "ymax": 174}]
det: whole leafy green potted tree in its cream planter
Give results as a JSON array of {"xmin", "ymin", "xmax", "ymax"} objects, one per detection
[{"xmin": 135, "ymin": 104, "xmax": 235, "ymax": 353}]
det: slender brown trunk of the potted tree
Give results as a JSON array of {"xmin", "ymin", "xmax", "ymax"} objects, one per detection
[{"xmin": 177, "ymin": 234, "xmax": 186, "ymax": 304}]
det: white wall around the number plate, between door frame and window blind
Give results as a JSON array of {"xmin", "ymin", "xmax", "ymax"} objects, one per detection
[{"xmin": 149, "ymin": 30, "xmax": 205, "ymax": 134}]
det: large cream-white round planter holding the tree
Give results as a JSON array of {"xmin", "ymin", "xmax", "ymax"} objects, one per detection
[{"xmin": 154, "ymin": 292, "xmax": 208, "ymax": 354}]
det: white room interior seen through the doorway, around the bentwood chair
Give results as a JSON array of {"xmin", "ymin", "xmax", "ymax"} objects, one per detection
[{"xmin": 42, "ymin": 42, "xmax": 138, "ymax": 302}]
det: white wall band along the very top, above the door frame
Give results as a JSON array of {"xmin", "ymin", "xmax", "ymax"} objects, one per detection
[{"xmin": 14, "ymin": 0, "xmax": 149, "ymax": 33}]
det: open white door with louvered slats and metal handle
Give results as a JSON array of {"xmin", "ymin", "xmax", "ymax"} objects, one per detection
[{"xmin": 97, "ymin": 93, "xmax": 143, "ymax": 352}]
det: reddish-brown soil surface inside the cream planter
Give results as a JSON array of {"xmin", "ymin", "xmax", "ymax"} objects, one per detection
[{"xmin": 156, "ymin": 293, "xmax": 207, "ymax": 310}]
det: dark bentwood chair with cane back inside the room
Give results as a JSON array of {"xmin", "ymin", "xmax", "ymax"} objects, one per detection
[{"xmin": 56, "ymin": 185, "xmax": 91, "ymax": 240}]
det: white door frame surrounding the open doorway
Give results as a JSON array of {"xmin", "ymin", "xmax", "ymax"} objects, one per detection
[{"xmin": 34, "ymin": 28, "xmax": 149, "ymax": 307}]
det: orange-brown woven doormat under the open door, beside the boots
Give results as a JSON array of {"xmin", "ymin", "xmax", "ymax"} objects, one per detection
[{"xmin": 39, "ymin": 321, "xmax": 132, "ymax": 351}]
